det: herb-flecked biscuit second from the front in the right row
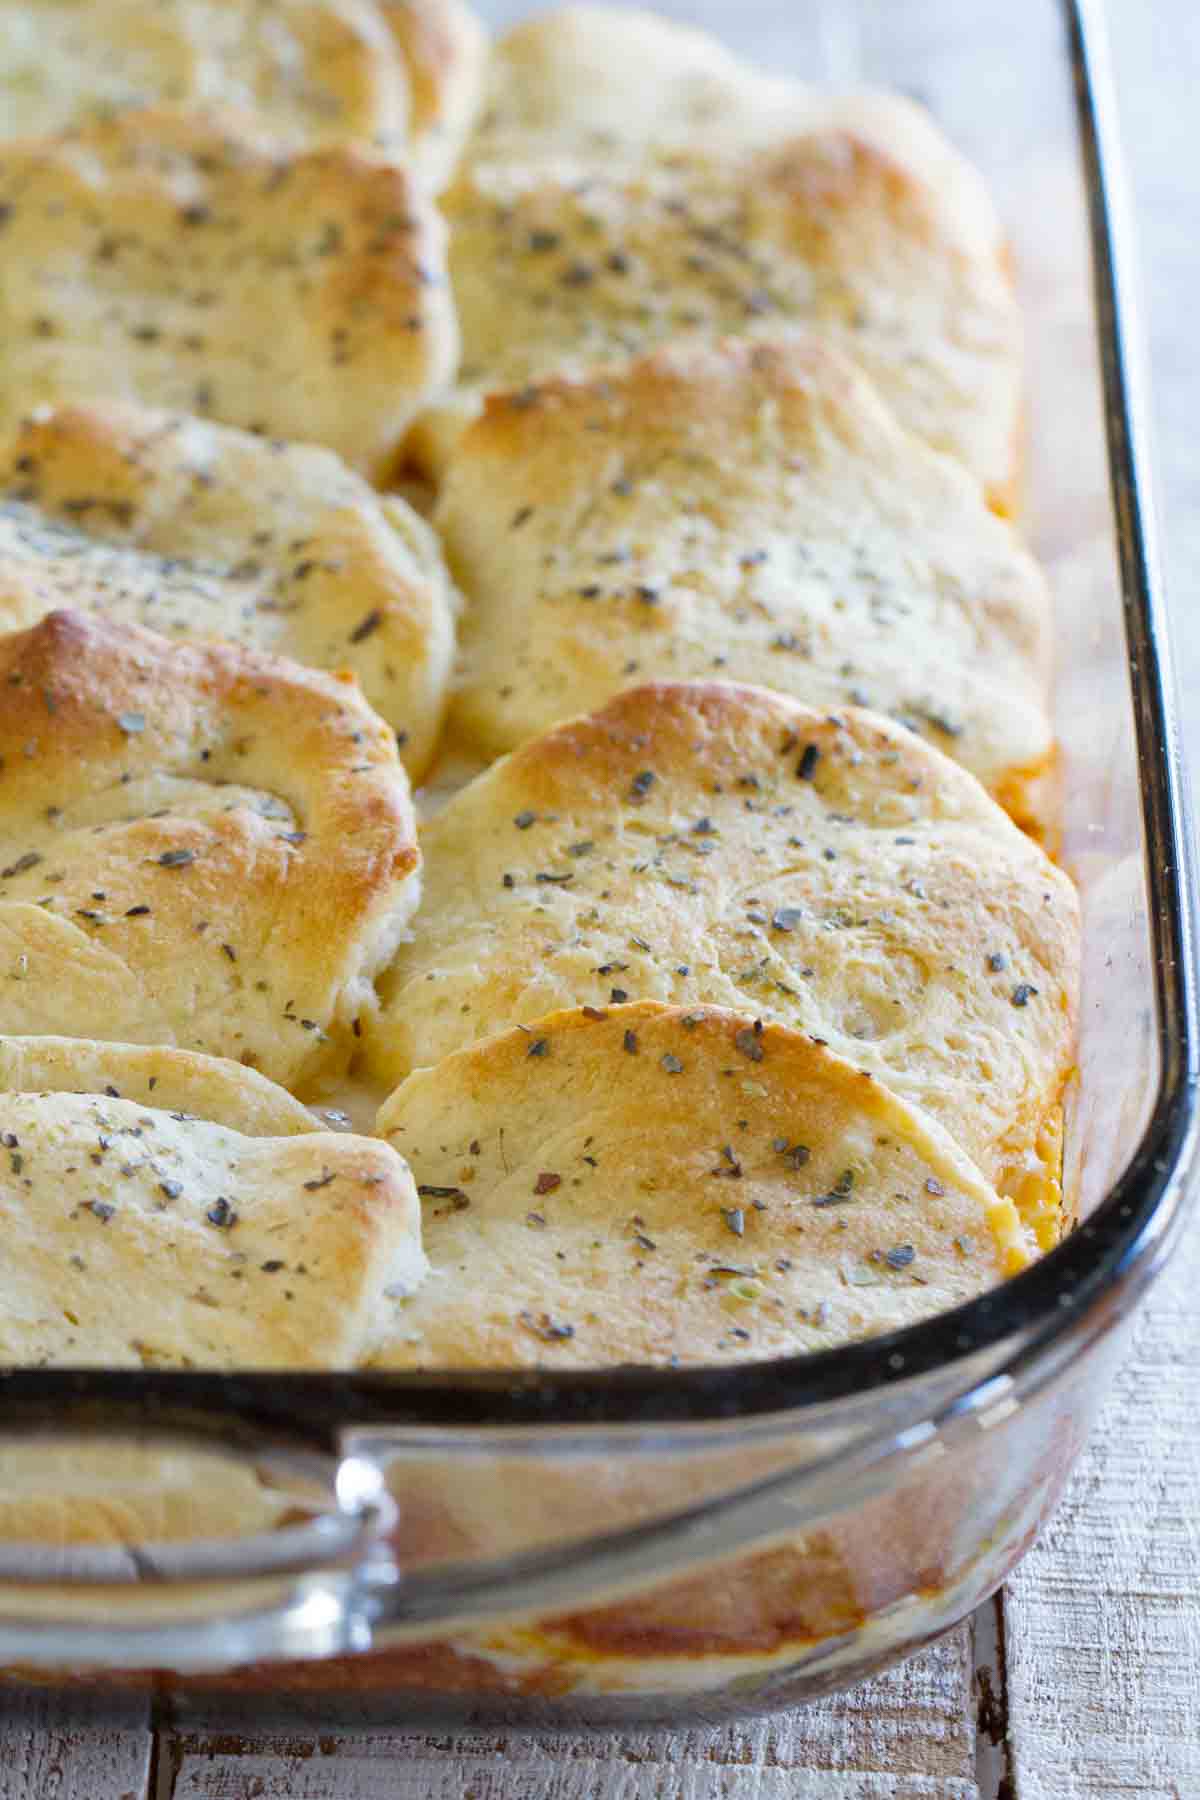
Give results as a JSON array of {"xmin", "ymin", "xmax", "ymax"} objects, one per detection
[{"xmin": 371, "ymin": 682, "xmax": 1079, "ymax": 1222}]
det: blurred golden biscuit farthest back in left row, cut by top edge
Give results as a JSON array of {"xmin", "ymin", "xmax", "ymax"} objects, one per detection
[{"xmin": 0, "ymin": 0, "xmax": 486, "ymax": 182}]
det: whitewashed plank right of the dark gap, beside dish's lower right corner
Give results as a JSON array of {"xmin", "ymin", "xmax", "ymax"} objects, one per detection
[{"xmin": 1004, "ymin": 1231, "xmax": 1200, "ymax": 1800}]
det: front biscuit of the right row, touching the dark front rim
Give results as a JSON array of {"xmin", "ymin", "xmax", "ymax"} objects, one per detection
[{"xmin": 378, "ymin": 1003, "xmax": 1034, "ymax": 1368}]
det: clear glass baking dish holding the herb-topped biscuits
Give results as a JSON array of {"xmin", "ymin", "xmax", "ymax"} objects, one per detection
[{"xmin": 0, "ymin": 0, "xmax": 1196, "ymax": 1726}]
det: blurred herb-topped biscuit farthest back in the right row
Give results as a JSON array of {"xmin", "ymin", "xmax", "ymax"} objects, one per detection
[{"xmin": 437, "ymin": 28, "xmax": 1022, "ymax": 508}]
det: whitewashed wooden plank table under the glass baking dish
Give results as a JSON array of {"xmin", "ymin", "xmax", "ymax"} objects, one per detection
[{"xmin": 0, "ymin": 0, "xmax": 1200, "ymax": 1800}]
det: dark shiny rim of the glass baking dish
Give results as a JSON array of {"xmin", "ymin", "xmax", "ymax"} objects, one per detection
[{"xmin": 0, "ymin": 0, "xmax": 1200, "ymax": 1449}]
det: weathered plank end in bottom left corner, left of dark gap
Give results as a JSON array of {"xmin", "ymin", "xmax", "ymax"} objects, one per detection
[{"xmin": 0, "ymin": 1690, "xmax": 153, "ymax": 1800}]
